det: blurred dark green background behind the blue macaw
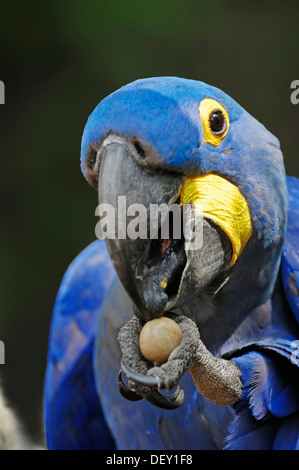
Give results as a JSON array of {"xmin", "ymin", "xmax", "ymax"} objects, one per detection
[{"xmin": 0, "ymin": 0, "xmax": 299, "ymax": 442}]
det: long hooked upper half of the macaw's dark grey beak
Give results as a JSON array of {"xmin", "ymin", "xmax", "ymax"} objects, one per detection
[{"xmin": 99, "ymin": 143, "xmax": 185, "ymax": 321}]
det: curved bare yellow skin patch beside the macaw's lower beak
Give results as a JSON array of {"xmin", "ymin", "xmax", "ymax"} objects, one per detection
[{"xmin": 180, "ymin": 174, "xmax": 252, "ymax": 265}]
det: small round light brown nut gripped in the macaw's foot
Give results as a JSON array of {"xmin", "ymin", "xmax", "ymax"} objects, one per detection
[{"xmin": 139, "ymin": 317, "xmax": 182, "ymax": 362}]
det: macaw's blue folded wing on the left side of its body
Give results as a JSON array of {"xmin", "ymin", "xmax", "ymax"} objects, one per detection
[{"xmin": 44, "ymin": 240, "xmax": 115, "ymax": 449}]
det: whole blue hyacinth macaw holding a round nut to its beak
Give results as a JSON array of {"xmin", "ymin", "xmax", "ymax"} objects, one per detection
[{"xmin": 44, "ymin": 77, "xmax": 299, "ymax": 450}]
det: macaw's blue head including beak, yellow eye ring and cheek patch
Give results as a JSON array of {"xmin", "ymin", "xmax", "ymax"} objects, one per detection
[{"xmin": 81, "ymin": 77, "xmax": 287, "ymax": 330}]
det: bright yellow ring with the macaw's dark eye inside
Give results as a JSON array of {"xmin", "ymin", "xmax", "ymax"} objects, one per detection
[{"xmin": 199, "ymin": 98, "xmax": 229, "ymax": 147}]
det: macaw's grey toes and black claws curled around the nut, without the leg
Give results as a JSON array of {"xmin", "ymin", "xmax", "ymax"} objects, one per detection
[{"xmin": 118, "ymin": 312, "xmax": 199, "ymax": 409}]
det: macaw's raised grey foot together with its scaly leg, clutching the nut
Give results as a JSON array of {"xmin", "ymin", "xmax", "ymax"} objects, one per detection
[{"xmin": 118, "ymin": 312, "xmax": 243, "ymax": 409}]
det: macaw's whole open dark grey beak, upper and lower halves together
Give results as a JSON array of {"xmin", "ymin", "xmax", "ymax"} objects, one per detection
[{"xmin": 98, "ymin": 140, "xmax": 232, "ymax": 321}]
